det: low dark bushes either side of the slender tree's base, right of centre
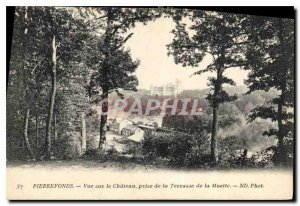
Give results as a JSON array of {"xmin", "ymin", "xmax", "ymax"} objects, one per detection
[{"xmin": 142, "ymin": 132, "xmax": 284, "ymax": 169}]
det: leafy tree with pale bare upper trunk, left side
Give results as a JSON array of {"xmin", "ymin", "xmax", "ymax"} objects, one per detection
[{"xmin": 37, "ymin": 7, "xmax": 86, "ymax": 157}]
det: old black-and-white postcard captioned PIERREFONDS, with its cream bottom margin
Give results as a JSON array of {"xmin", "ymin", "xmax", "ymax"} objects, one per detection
[{"xmin": 6, "ymin": 6, "xmax": 295, "ymax": 200}]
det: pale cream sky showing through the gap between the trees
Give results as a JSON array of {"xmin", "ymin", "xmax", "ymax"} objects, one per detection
[{"xmin": 126, "ymin": 18, "xmax": 247, "ymax": 89}]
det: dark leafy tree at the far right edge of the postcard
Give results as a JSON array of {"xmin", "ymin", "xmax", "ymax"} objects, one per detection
[{"xmin": 244, "ymin": 17, "xmax": 295, "ymax": 164}]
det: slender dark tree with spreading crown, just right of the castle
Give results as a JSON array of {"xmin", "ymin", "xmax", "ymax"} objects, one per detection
[{"xmin": 167, "ymin": 10, "xmax": 245, "ymax": 164}]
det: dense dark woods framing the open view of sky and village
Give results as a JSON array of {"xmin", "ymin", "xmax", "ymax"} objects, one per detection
[{"xmin": 6, "ymin": 7, "xmax": 295, "ymax": 168}]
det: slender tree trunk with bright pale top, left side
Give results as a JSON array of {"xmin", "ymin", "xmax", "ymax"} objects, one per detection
[{"xmin": 46, "ymin": 36, "xmax": 56, "ymax": 157}]
